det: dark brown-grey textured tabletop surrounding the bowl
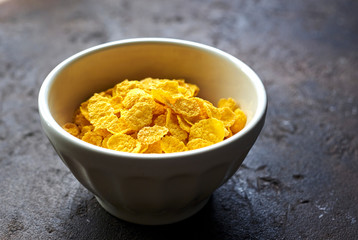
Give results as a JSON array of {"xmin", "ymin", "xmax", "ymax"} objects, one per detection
[{"xmin": 0, "ymin": 0, "xmax": 358, "ymax": 239}]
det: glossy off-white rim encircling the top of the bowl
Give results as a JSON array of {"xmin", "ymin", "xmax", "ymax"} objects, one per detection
[{"xmin": 38, "ymin": 38, "xmax": 267, "ymax": 160}]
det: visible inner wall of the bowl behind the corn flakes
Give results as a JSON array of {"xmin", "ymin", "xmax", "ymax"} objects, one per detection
[{"xmin": 47, "ymin": 41, "xmax": 260, "ymax": 125}]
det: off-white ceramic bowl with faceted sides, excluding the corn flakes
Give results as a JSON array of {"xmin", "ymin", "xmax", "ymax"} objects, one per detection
[{"xmin": 38, "ymin": 38, "xmax": 267, "ymax": 225}]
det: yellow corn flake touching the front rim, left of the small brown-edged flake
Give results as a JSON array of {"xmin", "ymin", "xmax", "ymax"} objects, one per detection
[{"xmin": 106, "ymin": 133, "xmax": 141, "ymax": 153}]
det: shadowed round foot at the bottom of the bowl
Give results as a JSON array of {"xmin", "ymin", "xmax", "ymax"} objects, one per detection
[{"xmin": 96, "ymin": 196, "xmax": 210, "ymax": 225}]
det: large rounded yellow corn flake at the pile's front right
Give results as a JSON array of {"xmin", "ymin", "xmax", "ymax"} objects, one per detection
[{"xmin": 189, "ymin": 118, "xmax": 225, "ymax": 143}]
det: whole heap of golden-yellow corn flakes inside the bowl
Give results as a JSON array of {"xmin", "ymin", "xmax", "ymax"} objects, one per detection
[{"xmin": 63, "ymin": 78, "xmax": 246, "ymax": 153}]
